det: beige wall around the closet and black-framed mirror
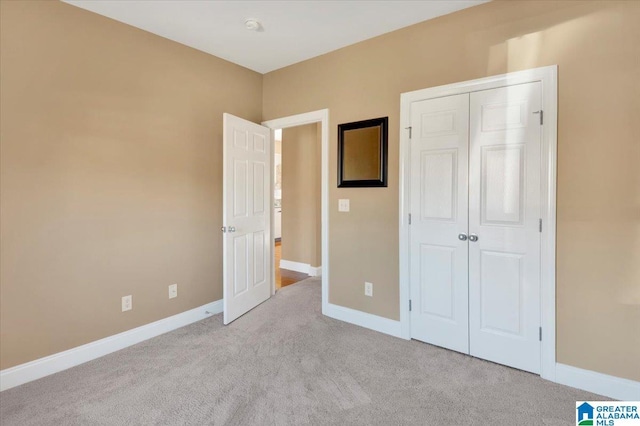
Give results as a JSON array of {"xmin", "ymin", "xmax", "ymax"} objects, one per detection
[{"xmin": 263, "ymin": 1, "xmax": 640, "ymax": 380}]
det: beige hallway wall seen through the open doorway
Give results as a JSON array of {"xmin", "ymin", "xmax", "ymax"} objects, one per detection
[{"xmin": 282, "ymin": 124, "xmax": 321, "ymax": 267}]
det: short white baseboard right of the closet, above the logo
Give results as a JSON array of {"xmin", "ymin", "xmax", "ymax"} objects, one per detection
[{"xmin": 555, "ymin": 363, "xmax": 640, "ymax": 401}]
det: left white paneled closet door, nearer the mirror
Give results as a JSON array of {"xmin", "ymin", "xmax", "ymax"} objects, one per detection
[{"xmin": 410, "ymin": 94, "xmax": 469, "ymax": 353}]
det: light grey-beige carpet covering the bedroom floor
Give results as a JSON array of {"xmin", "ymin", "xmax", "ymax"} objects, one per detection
[{"xmin": 0, "ymin": 278, "xmax": 603, "ymax": 426}]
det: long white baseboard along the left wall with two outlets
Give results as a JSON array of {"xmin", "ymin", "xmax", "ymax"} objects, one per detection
[{"xmin": 0, "ymin": 300, "xmax": 223, "ymax": 391}]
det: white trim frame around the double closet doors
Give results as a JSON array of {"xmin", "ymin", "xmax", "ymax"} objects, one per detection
[{"xmin": 399, "ymin": 65, "xmax": 558, "ymax": 381}]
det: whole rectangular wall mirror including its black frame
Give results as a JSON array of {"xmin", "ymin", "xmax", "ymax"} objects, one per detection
[{"xmin": 338, "ymin": 117, "xmax": 389, "ymax": 188}]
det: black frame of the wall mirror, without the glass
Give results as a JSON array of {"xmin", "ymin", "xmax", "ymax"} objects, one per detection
[{"xmin": 338, "ymin": 117, "xmax": 389, "ymax": 188}]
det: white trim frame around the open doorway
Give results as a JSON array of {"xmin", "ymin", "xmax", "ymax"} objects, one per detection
[{"xmin": 262, "ymin": 108, "xmax": 329, "ymax": 313}]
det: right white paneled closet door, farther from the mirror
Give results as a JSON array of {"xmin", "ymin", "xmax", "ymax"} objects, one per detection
[{"xmin": 469, "ymin": 83, "xmax": 541, "ymax": 373}]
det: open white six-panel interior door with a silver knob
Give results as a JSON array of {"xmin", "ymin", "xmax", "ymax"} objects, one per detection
[{"xmin": 222, "ymin": 113, "xmax": 272, "ymax": 324}]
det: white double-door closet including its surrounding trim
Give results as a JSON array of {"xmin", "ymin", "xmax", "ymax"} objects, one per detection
[{"xmin": 400, "ymin": 67, "xmax": 557, "ymax": 380}]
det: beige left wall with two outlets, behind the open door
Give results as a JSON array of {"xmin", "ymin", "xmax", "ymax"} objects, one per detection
[{"xmin": 0, "ymin": 1, "xmax": 262, "ymax": 369}]
